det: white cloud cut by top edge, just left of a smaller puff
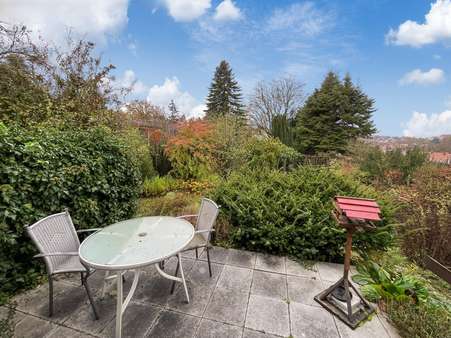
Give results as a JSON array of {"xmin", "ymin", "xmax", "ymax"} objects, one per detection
[{"xmin": 163, "ymin": 0, "xmax": 211, "ymax": 22}]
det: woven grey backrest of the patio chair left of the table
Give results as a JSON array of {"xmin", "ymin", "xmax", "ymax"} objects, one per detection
[{"xmin": 26, "ymin": 211, "xmax": 80, "ymax": 274}]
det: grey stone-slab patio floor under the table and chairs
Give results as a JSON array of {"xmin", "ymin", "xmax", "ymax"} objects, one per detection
[{"xmin": 0, "ymin": 247, "xmax": 398, "ymax": 338}]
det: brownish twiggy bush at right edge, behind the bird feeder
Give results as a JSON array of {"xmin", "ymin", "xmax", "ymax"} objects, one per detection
[{"xmin": 399, "ymin": 165, "xmax": 451, "ymax": 266}]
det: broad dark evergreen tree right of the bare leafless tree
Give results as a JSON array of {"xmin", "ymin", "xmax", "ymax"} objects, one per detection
[{"xmin": 296, "ymin": 72, "xmax": 376, "ymax": 154}]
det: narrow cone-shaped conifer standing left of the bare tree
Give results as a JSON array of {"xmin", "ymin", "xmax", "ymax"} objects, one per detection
[{"xmin": 205, "ymin": 60, "xmax": 245, "ymax": 118}]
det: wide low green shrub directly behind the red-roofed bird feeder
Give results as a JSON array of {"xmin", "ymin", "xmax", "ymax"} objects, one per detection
[{"xmin": 213, "ymin": 166, "xmax": 394, "ymax": 261}]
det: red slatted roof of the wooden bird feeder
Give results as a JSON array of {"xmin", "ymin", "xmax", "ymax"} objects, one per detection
[{"xmin": 335, "ymin": 196, "xmax": 381, "ymax": 221}]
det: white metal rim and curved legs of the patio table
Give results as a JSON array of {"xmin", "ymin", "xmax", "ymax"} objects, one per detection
[{"xmin": 79, "ymin": 216, "xmax": 194, "ymax": 338}]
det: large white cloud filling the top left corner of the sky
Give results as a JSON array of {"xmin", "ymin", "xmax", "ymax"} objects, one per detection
[{"xmin": 0, "ymin": 0, "xmax": 128, "ymax": 44}]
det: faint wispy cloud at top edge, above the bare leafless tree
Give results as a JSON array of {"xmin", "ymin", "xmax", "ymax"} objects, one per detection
[{"xmin": 267, "ymin": 1, "xmax": 334, "ymax": 36}]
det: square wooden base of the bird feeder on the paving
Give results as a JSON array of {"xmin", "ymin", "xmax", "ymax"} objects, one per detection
[{"xmin": 315, "ymin": 277, "xmax": 375, "ymax": 329}]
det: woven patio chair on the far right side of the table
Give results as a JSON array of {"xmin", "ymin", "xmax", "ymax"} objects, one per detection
[{"xmin": 171, "ymin": 198, "xmax": 219, "ymax": 293}]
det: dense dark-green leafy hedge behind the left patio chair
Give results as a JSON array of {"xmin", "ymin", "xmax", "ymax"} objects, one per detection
[{"xmin": 0, "ymin": 123, "xmax": 141, "ymax": 298}]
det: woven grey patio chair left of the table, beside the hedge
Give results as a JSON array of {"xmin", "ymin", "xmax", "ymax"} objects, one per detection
[{"xmin": 26, "ymin": 210, "xmax": 99, "ymax": 319}]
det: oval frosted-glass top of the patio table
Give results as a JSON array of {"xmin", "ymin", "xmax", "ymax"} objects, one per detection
[{"xmin": 79, "ymin": 216, "xmax": 194, "ymax": 270}]
